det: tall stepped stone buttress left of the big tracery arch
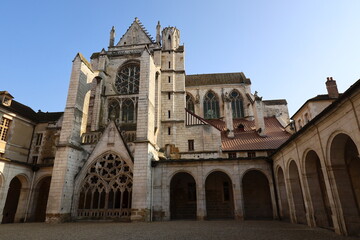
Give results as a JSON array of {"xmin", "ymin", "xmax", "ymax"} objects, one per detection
[{"xmin": 46, "ymin": 53, "xmax": 95, "ymax": 222}]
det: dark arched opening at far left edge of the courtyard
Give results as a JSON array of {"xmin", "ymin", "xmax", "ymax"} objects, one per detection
[{"xmin": 2, "ymin": 177, "xmax": 21, "ymax": 223}]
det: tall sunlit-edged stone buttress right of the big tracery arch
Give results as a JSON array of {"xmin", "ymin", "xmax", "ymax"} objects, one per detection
[{"xmin": 131, "ymin": 50, "xmax": 156, "ymax": 221}]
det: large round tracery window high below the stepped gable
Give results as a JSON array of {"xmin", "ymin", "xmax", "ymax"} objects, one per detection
[{"xmin": 115, "ymin": 63, "xmax": 140, "ymax": 94}]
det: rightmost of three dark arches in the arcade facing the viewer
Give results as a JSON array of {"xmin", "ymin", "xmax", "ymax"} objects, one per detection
[{"xmin": 242, "ymin": 170, "xmax": 273, "ymax": 219}]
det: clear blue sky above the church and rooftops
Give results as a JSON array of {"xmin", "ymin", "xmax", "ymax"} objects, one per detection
[{"xmin": 0, "ymin": 0, "xmax": 360, "ymax": 115}]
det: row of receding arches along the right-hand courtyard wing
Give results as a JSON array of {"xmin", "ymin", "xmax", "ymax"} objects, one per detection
[{"xmin": 274, "ymin": 132, "xmax": 360, "ymax": 235}]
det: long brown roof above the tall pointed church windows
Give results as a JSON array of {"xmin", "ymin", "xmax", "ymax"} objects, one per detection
[{"xmin": 185, "ymin": 72, "xmax": 251, "ymax": 87}]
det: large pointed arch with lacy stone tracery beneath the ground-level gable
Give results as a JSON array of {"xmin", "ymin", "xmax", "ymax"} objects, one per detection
[{"xmin": 78, "ymin": 153, "xmax": 133, "ymax": 220}]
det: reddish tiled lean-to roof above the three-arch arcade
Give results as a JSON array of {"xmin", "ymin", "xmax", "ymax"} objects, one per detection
[{"xmin": 206, "ymin": 117, "xmax": 291, "ymax": 151}]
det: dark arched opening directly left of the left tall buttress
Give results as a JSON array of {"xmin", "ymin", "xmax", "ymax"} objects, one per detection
[{"xmin": 34, "ymin": 177, "xmax": 51, "ymax": 222}]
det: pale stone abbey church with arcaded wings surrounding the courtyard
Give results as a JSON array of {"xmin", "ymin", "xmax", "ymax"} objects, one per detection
[{"xmin": 0, "ymin": 18, "xmax": 360, "ymax": 235}]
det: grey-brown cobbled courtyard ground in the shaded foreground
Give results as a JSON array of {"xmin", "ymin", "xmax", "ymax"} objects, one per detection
[{"xmin": 0, "ymin": 221, "xmax": 360, "ymax": 240}]
